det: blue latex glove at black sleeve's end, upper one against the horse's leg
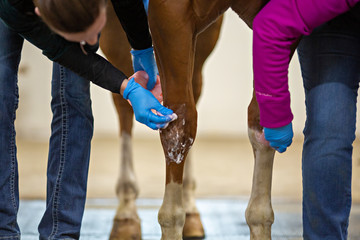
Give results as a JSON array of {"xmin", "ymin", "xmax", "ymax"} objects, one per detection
[{"xmin": 130, "ymin": 47, "xmax": 159, "ymax": 90}]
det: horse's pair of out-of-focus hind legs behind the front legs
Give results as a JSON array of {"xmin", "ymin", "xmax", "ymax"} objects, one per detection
[{"xmin": 100, "ymin": 1, "xmax": 223, "ymax": 240}]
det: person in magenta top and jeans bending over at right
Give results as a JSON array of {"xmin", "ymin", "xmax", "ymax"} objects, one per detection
[{"xmin": 254, "ymin": 0, "xmax": 360, "ymax": 240}]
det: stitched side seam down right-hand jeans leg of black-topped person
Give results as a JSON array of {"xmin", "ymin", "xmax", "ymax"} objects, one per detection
[{"xmin": 49, "ymin": 66, "xmax": 68, "ymax": 239}]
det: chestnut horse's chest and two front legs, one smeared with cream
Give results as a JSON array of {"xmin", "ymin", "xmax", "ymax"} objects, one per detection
[{"xmin": 148, "ymin": 0, "xmax": 282, "ymax": 240}]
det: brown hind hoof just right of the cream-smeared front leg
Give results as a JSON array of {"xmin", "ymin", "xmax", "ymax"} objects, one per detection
[{"xmin": 183, "ymin": 213, "xmax": 205, "ymax": 240}]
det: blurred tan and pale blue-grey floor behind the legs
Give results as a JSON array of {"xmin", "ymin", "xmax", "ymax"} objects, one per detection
[{"xmin": 18, "ymin": 137, "xmax": 360, "ymax": 240}]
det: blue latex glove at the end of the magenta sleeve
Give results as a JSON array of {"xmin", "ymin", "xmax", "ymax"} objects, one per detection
[{"xmin": 264, "ymin": 123, "xmax": 294, "ymax": 153}]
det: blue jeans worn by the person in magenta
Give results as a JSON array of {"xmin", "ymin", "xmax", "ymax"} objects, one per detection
[{"xmin": 298, "ymin": 4, "xmax": 360, "ymax": 240}]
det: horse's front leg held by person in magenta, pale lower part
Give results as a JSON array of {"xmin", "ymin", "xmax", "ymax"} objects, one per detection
[{"xmin": 245, "ymin": 91, "xmax": 275, "ymax": 240}]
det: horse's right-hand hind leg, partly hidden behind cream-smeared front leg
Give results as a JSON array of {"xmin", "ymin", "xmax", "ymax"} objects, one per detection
[{"xmin": 183, "ymin": 17, "xmax": 222, "ymax": 239}]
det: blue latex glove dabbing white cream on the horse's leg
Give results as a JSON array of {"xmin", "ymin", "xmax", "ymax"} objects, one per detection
[{"xmin": 123, "ymin": 78, "xmax": 174, "ymax": 130}]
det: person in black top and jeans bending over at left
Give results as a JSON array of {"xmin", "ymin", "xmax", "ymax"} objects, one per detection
[{"xmin": 0, "ymin": 0, "xmax": 174, "ymax": 239}]
